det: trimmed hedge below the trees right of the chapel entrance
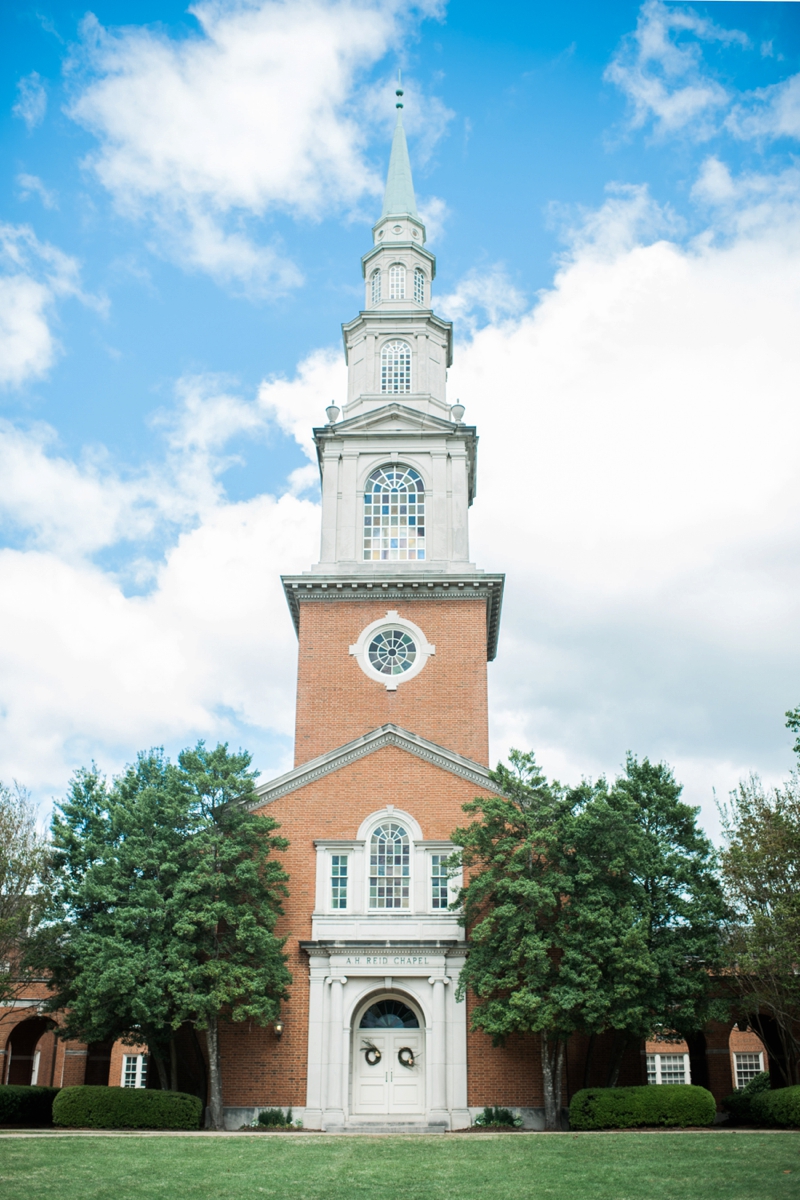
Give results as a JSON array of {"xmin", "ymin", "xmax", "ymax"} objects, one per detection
[{"xmin": 570, "ymin": 1084, "xmax": 716, "ymax": 1129}]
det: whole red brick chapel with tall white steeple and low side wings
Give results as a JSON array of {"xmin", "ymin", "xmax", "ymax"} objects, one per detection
[{"xmin": 0, "ymin": 92, "xmax": 766, "ymax": 1130}]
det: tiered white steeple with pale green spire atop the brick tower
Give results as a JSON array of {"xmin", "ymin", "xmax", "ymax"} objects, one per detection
[{"xmin": 304, "ymin": 88, "xmax": 477, "ymax": 587}]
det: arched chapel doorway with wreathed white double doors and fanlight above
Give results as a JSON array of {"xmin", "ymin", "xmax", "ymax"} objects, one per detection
[{"xmin": 353, "ymin": 992, "xmax": 425, "ymax": 1117}]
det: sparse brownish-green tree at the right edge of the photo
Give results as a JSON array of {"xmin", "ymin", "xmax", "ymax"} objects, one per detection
[{"xmin": 721, "ymin": 768, "xmax": 800, "ymax": 1085}]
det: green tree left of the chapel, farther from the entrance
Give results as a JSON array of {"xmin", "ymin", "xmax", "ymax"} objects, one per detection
[{"xmin": 31, "ymin": 750, "xmax": 193, "ymax": 1087}]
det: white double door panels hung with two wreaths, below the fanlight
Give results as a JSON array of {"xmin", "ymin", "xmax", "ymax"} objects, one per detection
[{"xmin": 353, "ymin": 1028, "xmax": 425, "ymax": 1116}]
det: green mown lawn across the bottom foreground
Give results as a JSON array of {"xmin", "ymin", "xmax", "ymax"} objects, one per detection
[{"xmin": 0, "ymin": 1132, "xmax": 800, "ymax": 1200}]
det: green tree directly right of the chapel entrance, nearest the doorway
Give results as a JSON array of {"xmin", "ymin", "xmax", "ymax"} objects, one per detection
[{"xmin": 452, "ymin": 751, "xmax": 651, "ymax": 1129}]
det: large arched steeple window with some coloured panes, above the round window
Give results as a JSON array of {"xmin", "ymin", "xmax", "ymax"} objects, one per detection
[{"xmin": 363, "ymin": 464, "xmax": 425, "ymax": 563}]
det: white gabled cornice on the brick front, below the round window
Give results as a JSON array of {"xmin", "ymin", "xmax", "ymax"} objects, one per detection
[{"xmin": 249, "ymin": 725, "xmax": 501, "ymax": 809}]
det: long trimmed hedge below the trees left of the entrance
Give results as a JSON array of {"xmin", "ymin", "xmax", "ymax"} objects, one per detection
[{"xmin": 53, "ymin": 1084, "xmax": 203, "ymax": 1129}]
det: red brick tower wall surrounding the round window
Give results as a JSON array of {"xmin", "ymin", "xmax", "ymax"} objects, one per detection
[{"xmin": 295, "ymin": 599, "xmax": 489, "ymax": 766}]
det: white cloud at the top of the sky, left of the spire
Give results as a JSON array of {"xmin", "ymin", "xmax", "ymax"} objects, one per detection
[{"xmin": 70, "ymin": 0, "xmax": 446, "ymax": 292}]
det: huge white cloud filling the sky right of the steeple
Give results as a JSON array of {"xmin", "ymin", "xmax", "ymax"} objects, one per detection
[{"xmin": 438, "ymin": 174, "xmax": 800, "ymax": 823}]
